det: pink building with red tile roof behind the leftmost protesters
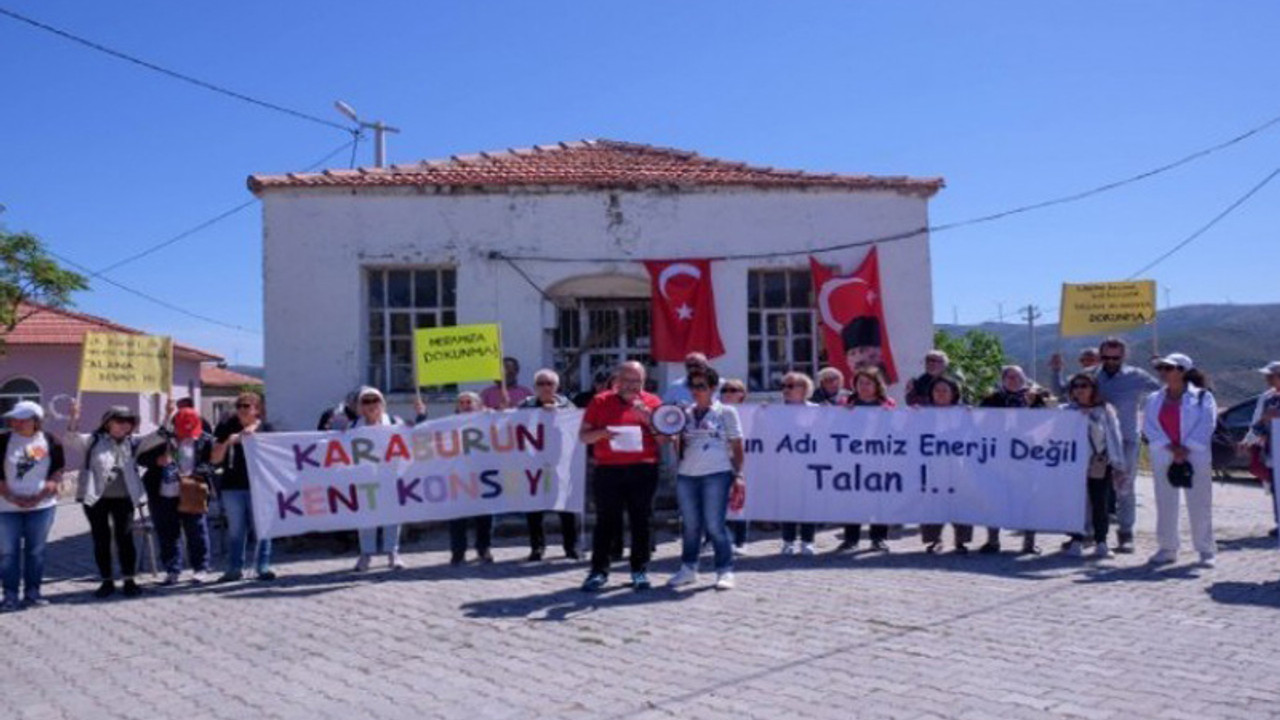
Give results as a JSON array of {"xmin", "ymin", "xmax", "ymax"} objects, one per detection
[{"xmin": 0, "ymin": 305, "xmax": 221, "ymax": 432}]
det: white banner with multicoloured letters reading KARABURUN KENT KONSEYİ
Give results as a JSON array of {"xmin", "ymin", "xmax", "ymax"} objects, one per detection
[{"xmin": 244, "ymin": 410, "xmax": 586, "ymax": 538}]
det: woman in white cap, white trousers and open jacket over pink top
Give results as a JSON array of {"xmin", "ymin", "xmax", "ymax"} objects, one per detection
[{"xmin": 1142, "ymin": 352, "xmax": 1217, "ymax": 568}]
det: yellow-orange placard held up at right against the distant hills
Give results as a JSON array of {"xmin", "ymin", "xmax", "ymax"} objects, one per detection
[{"xmin": 1060, "ymin": 281, "xmax": 1156, "ymax": 337}]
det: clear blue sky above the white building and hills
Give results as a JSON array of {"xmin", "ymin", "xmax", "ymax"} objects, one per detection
[{"xmin": 0, "ymin": 0, "xmax": 1280, "ymax": 363}]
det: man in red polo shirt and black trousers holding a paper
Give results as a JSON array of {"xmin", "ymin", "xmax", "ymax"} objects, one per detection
[{"xmin": 579, "ymin": 361, "xmax": 666, "ymax": 592}]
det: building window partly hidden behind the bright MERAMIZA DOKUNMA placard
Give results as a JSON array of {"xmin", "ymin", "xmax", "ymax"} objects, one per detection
[{"xmin": 366, "ymin": 268, "xmax": 458, "ymax": 392}]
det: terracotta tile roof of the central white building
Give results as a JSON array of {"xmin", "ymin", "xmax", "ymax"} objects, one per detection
[{"xmin": 248, "ymin": 140, "xmax": 945, "ymax": 197}]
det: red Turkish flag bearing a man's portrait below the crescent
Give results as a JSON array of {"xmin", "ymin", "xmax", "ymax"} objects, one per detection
[{"xmin": 809, "ymin": 247, "xmax": 897, "ymax": 384}]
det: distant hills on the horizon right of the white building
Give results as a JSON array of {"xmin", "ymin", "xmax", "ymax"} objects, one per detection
[{"xmin": 937, "ymin": 299, "xmax": 1280, "ymax": 407}]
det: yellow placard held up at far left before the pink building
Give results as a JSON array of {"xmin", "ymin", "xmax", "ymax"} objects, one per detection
[{"xmin": 79, "ymin": 333, "xmax": 173, "ymax": 393}]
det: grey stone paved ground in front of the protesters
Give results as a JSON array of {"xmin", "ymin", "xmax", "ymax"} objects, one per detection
[{"xmin": 0, "ymin": 471, "xmax": 1280, "ymax": 720}]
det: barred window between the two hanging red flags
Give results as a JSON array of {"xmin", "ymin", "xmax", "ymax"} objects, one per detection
[{"xmin": 746, "ymin": 270, "xmax": 823, "ymax": 391}]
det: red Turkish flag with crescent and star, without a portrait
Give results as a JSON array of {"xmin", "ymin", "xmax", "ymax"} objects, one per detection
[{"xmin": 645, "ymin": 260, "xmax": 724, "ymax": 363}]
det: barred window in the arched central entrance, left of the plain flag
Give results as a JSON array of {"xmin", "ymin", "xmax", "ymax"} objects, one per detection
[{"xmin": 553, "ymin": 299, "xmax": 654, "ymax": 393}]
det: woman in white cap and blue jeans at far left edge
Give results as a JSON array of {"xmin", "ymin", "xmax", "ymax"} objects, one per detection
[{"xmin": 0, "ymin": 401, "xmax": 65, "ymax": 612}]
